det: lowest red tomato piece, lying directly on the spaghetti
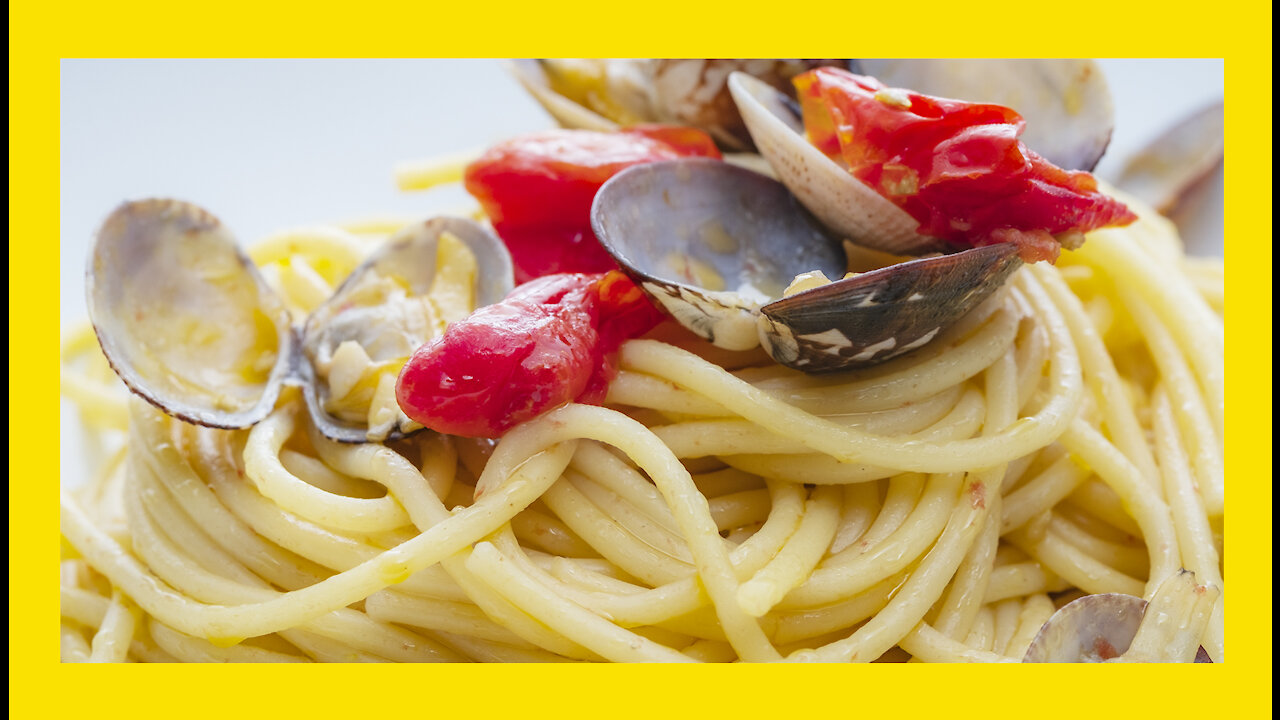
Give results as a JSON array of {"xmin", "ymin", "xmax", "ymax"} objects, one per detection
[{"xmin": 396, "ymin": 270, "xmax": 662, "ymax": 437}]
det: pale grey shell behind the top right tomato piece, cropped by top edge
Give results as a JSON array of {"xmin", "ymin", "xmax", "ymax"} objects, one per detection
[{"xmin": 859, "ymin": 58, "xmax": 1115, "ymax": 170}]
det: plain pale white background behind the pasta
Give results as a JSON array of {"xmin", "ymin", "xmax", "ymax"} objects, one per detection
[{"xmin": 59, "ymin": 60, "xmax": 1222, "ymax": 479}]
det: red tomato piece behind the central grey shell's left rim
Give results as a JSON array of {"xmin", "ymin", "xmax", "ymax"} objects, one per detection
[{"xmin": 465, "ymin": 126, "xmax": 719, "ymax": 283}]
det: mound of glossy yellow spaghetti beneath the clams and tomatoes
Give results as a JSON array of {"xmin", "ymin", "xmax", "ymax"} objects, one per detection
[{"xmin": 61, "ymin": 194, "xmax": 1224, "ymax": 662}]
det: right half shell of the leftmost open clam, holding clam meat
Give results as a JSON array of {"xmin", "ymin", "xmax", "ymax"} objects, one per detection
[{"xmin": 302, "ymin": 218, "xmax": 513, "ymax": 442}]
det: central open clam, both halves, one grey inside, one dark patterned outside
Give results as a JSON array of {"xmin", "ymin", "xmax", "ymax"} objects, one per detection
[{"xmin": 591, "ymin": 159, "xmax": 1021, "ymax": 373}]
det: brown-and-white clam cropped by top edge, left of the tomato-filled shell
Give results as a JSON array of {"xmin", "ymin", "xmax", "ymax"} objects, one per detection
[{"xmin": 512, "ymin": 59, "xmax": 850, "ymax": 151}]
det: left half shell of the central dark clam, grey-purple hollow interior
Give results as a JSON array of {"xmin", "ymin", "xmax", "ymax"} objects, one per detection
[{"xmin": 591, "ymin": 159, "xmax": 845, "ymax": 350}]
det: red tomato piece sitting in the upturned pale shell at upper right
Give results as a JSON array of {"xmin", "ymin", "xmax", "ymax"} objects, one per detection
[{"xmin": 795, "ymin": 68, "xmax": 1137, "ymax": 261}]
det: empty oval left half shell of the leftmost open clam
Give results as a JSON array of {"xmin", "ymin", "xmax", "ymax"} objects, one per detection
[{"xmin": 87, "ymin": 199, "xmax": 296, "ymax": 428}]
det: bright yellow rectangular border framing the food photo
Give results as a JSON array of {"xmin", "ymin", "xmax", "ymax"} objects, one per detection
[{"xmin": 9, "ymin": 0, "xmax": 1272, "ymax": 719}]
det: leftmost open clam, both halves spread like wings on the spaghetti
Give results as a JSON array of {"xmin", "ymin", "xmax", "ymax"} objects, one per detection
[{"xmin": 87, "ymin": 200, "xmax": 512, "ymax": 442}]
